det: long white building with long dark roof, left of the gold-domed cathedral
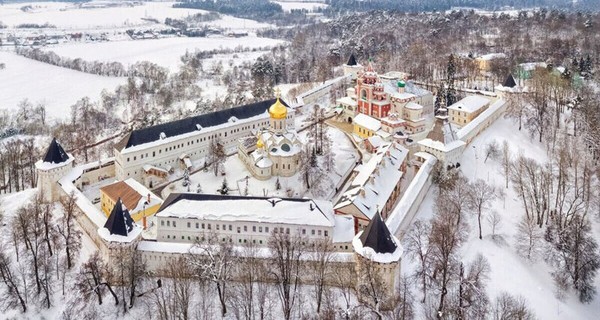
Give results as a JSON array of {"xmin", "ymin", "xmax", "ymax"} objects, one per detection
[{"xmin": 114, "ymin": 99, "xmax": 294, "ymax": 187}]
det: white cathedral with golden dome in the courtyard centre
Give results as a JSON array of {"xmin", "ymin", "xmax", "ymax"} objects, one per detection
[{"xmin": 238, "ymin": 92, "xmax": 303, "ymax": 180}]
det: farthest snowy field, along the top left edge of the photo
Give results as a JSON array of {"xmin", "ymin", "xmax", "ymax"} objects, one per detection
[{"xmin": 0, "ymin": 1, "xmax": 270, "ymax": 30}]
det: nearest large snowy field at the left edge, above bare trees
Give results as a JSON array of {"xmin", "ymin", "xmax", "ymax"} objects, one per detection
[{"xmin": 0, "ymin": 51, "xmax": 126, "ymax": 119}]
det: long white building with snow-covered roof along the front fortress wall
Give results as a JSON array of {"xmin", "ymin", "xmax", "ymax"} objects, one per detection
[{"xmin": 156, "ymin": 193, "xmax": 354, "ymax": 250}]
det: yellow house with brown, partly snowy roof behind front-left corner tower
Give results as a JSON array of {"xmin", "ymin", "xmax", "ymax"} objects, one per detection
[{"xmin": 100, "ymin": 178, "xmax": 163, "ymax": 222}]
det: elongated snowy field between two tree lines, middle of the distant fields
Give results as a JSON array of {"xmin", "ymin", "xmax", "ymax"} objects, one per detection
[{"xmin": 47, "ymin": 36, "xmax": 284, "ymax": 71}]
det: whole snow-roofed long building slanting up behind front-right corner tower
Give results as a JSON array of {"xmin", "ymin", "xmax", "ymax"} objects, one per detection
[{"xmin": 334, "ymin": 142, "xmax": 408, "ymax": 230}]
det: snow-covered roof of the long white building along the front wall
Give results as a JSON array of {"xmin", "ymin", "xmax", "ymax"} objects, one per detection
[{"xmin": 156, "ymin": 193, "xmax": 334, "ymax": 227}]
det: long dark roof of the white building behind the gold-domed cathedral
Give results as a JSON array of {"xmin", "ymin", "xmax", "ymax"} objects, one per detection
[{"xmin": 115, "ymin": 99, "xmax": 289, "ymax": 151}]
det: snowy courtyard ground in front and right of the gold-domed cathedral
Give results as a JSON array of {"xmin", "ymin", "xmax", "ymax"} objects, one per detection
[{"xmin": 161, "ymin": 127, "xmax": 357, "ymax": 199}]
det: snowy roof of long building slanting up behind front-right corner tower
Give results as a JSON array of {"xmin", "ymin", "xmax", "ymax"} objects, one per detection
[{"xmin": 335, "ymin": 143, "xmax": 408, "ymax": 219}]
